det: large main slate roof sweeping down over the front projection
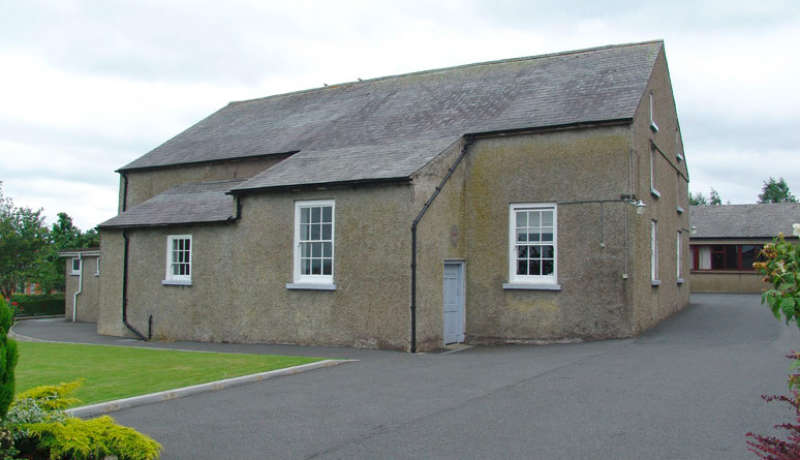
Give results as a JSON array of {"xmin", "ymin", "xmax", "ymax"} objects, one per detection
[{"xmin": 120, "ymin": 41, "xmax": 663, "ymax": 190}]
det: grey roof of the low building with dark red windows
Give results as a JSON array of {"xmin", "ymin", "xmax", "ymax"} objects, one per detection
[{"xmin": 689, "ymin": 203, "xmax": 800, "ymax": 238}]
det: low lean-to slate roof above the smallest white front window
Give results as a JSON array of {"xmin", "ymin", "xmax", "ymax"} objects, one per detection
[{"xmin": 99, "ymin": 179, "xmax": 243, "ymax": 228}]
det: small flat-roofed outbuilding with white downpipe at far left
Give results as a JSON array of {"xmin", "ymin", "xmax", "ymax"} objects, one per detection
[{"xmin": 58, "ymin": 248, "xmax": 101, "ymax": 323}]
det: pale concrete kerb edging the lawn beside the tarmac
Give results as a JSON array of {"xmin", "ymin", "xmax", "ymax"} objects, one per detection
[{"xmin": 66, "ymin": 359, "xmax": 358, "ymax": 418}]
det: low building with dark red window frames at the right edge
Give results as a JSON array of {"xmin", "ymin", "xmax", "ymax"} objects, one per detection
[{"xmin": 690, "ymin": 203, "xmax": 800, "ymax": 293}]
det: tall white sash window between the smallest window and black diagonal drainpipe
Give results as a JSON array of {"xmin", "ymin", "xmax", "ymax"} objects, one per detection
[{"xmin": 294, "ymin": 200, "xmax": 335, "ymax": 284}]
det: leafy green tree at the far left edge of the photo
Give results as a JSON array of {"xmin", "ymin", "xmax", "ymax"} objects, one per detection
[{"xmin": 0, "ymin": 182, "xmax": 48, "ymax": 298}]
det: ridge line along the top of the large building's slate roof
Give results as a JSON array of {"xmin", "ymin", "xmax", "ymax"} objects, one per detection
[{"xmin": 228, "ymin": 39, "xmax": 664, "ymax": 106}]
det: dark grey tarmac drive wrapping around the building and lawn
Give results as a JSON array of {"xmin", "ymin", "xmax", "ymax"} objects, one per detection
[{"xmin": 15, "ymin": 295, "xmax": 800, "ymax": 459}]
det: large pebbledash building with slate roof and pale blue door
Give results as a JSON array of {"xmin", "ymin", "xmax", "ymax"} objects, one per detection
[{"xmin": 64, "ymin": 41, "xmax": 689, "ymax": 351}]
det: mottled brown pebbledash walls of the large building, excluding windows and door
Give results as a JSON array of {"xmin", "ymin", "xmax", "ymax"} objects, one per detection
[{"xmin": 98, "ymin": 46, "xmax": 689, "ymax": 351}]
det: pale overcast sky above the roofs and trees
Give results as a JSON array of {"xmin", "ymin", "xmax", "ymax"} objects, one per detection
[{"xmin": 0, "ymin": 0, "xmax": 800, "ymax": 230}]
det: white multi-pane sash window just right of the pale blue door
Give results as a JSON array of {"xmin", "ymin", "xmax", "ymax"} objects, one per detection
[{"xmin": 509, "ymin": 204, "xmax": 558, "ymax": 284}]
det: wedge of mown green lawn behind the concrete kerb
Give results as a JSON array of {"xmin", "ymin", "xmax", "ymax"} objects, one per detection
[{"xmin": 16, "ymin": 341, "xmax": 323, "ymax": 405}]
